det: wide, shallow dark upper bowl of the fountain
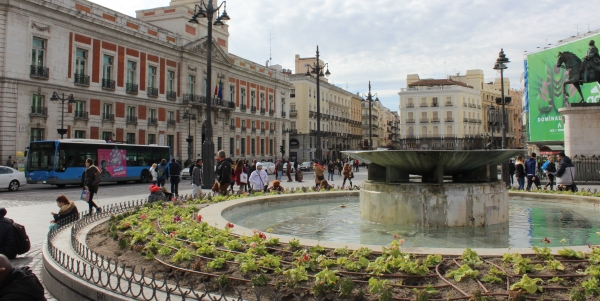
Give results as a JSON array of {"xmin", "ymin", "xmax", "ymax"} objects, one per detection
[{"xmin": 342, "ymin": 149, "xmax": 524, "ymax": 175}]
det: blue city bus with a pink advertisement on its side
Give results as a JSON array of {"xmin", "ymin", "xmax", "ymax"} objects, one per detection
[{"xmin": 25, "ymin": 139, "xmax": 171, "ymax": 187}]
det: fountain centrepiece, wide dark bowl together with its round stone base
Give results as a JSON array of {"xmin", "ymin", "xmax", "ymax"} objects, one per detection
[{"xmin": 343, "ymin": 150, "xmax": 523, "ymax": 227}]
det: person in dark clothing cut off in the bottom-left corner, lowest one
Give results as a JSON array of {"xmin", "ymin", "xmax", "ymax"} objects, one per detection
[{"xmin": 0, "ymin": 255, "xmax": 46, "ymax": 301}]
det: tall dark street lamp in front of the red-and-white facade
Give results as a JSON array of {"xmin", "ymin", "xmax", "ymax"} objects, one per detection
[{"xmin": 188, "ymin": 0, "xmax": 230, "ymax": 189}]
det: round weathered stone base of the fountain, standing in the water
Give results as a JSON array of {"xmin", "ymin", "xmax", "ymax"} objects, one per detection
[{"xmin": 360, "ymin": 181, "xmax": 508, "ymax": 227}]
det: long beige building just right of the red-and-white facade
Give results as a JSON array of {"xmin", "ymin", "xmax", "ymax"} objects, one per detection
[{"xmin": 286, "ymin": 55, "xmax": 361, "ymax": 162}]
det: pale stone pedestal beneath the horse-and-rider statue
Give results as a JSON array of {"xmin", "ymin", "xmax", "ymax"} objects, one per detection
[{"xmin": 558, "ymin": 103, "xmax": 600, "ymax": 158}]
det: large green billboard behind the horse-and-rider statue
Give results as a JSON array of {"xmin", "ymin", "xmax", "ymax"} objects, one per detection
[{"xmin": 525, "ymin": 34, "xmax": 600, "ymax": 142}]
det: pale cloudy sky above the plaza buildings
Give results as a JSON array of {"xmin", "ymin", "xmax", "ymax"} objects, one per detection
[{"xmin": 93, "ymin": 0, "xmax": 600, "ymax": 111}]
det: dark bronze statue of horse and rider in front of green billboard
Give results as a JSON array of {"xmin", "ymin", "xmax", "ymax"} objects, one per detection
[{"xmin": 556, "ymin": 40, "xmax": 600, "ymax": 103}]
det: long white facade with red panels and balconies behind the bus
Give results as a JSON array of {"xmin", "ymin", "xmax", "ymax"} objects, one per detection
[{"xmin": 0, "ymin": 0, "xmax": 291, "ymax": 161}]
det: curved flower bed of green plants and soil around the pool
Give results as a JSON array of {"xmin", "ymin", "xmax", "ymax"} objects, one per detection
[{"xmin": 87, "ymin": 205, "xmax": 600, "ymax": 300}]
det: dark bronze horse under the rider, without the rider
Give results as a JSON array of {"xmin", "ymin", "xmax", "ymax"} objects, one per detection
[{"xmin": 556, "ymin": 51, "xmax": 600, "ymax": 103}]
